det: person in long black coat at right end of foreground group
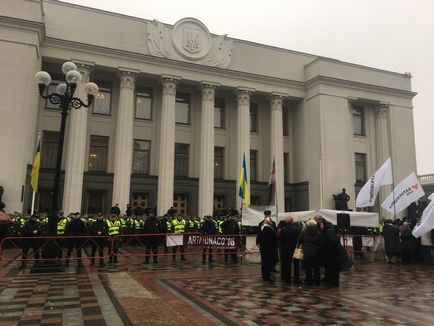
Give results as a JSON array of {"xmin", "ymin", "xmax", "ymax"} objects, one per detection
[{"xmin": 318, "ymin": 219, "xmax": 342, "ymax": 287}]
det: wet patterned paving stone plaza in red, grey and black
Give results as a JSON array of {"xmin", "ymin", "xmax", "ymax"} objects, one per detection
[{"xmin": 0, "ymin": 256, "xmax": 434, "ymax": 326}]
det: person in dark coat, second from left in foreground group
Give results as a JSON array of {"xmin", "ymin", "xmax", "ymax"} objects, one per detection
[{"xmin": 278, "ymin": 216, "xmax": 300, "ymax": 283}]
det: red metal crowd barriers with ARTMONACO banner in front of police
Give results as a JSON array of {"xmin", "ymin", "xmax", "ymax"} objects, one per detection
[{"xmin": 0, "ymin": 232, "xmax": 382, "ymax": 269}]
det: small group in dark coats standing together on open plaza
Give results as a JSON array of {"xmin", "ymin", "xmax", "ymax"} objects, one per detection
[{"xmin": 256, "ymin": 211, "xmax": 349, "ymax": 287}]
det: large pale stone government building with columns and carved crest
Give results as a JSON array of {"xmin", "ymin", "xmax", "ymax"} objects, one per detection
[{"xmin": 0, "ymin": 0, "xmax": 416, "ymax": 216}]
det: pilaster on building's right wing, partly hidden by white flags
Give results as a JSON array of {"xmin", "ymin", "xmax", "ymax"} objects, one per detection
[{"xmin": 376, "ymin": 105, "xmax": 393, "ymax": 217}]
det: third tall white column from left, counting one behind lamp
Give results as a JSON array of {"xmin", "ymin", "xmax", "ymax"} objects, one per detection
[{"xmin": 157, "ymin": 76, "xmax": 180, "ymax": 216}]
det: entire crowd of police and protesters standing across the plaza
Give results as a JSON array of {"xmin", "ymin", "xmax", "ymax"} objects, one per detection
[{"xmin": 2, "ymin": 205, "xmax": 434, "ymax": 276}]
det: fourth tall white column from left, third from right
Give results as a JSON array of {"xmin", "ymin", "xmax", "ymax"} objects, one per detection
[{"xmin": 199, "ymin": 83, "xmax": 217, "ymax": 217}]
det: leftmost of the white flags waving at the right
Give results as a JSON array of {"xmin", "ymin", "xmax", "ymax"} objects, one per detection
[{"xmin": 356, "ymin": 157, "xmax": 393, "ymax": 207}]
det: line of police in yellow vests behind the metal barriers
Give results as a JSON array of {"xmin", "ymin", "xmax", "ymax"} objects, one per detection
[{"xmin": 11, "ymin": 205, "xmax": 241, "ymax": 267}]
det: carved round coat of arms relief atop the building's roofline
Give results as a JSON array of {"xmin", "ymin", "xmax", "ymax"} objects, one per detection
[{"xmin": 147, "ymin": 18, "xmax": 233, "ymax": 68}]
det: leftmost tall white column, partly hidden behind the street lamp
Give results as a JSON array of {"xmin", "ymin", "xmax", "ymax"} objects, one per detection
[{"xmin": 62, "ymin": 64, "xmax": 92, "ymax": 214}]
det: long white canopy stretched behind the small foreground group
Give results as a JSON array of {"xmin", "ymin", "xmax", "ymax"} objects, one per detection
[{"xmin": 242, "ymin": 206, "xmax": 379, "ymax": 227}]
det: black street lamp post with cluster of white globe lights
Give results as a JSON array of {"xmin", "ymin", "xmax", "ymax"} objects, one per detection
[{"xmin": 35, "ymin": 62, "xmax": 98, "ymax": 258}]
